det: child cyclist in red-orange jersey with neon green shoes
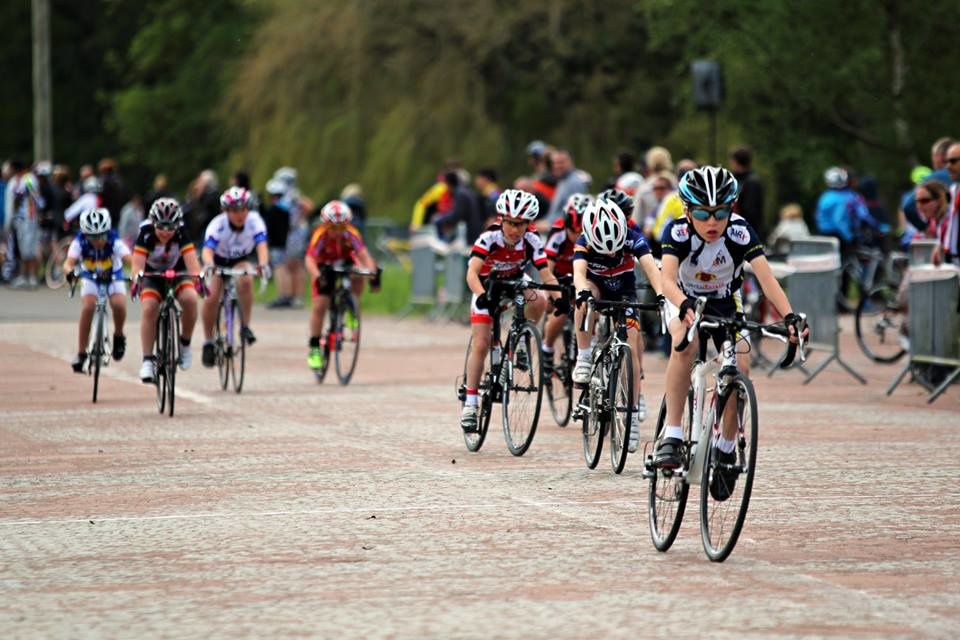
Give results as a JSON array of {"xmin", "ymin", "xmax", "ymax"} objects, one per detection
[{"xmin": 303, "ymin": 200, "xmax": 380, "ymax": 369}]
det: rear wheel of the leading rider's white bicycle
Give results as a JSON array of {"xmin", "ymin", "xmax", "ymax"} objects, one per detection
[{"xmin": 647, "ymin": 389, "xmax": 693, "ymax": 552}]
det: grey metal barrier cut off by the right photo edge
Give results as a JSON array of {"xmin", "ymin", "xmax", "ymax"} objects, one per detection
[{"xmin": 887, "ymin": 266, "xmax": 960, "ymax": 403}]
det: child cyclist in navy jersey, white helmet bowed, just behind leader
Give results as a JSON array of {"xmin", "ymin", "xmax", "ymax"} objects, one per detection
[{"xmin": 573, "ymin": 190, "xmax": 663, "ymax": 453}]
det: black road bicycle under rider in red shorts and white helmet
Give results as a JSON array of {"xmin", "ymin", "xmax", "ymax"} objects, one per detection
[{"xmin": 457, "ymin": 280, "xmax": 563, "ymax": 456}]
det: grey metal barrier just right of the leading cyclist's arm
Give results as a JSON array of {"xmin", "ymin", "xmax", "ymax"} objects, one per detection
[{"xmin": 787, "ymin": 254, "xmax": 867, "ymax": 384}]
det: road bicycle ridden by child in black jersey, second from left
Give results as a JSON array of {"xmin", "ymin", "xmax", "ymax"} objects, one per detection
[{"xmin": 139, "ymin": 269, "xmax": 199, "ymax": 418}]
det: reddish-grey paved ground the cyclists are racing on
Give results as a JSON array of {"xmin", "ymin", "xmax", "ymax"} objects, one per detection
[{"xmin": 0, "ymin": 290, "xmax": 960, "ymax": 638}]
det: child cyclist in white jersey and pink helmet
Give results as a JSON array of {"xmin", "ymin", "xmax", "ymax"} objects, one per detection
[{"xmin": 201, "ymin": 187, "xmax": 271, "ymax": 369}]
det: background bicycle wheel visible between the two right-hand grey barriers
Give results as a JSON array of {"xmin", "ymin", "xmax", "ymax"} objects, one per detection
[{"xmin": 854, "ymin": 286, "xmax": 907, "ymax": 364}]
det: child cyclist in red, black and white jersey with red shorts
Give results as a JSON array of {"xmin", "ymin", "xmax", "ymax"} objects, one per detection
[{"xmin": 460, "ymin": 189, "xmax": 570, "ymax": 433}]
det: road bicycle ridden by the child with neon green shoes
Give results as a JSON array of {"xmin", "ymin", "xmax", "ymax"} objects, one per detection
[{"xmin": 314, "ymin": 267, "xmax": 377, "ymax": 385}]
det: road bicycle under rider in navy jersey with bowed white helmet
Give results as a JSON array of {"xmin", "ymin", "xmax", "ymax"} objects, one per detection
[{"xmin": 573, "ymin": 300, "xmax": 663, "ymax": 473}]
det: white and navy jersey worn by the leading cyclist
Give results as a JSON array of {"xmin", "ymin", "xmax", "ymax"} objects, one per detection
[{"xmin": 663, "ymin": 214, "xmax": 764, "ymax": 299}]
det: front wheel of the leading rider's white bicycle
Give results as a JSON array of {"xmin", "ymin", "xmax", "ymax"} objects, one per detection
[{"xmin": 700, "ymin": 375, "xmax": 757, "ymax": 562}]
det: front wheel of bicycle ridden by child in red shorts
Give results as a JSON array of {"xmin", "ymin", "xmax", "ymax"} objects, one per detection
[{"xmin": 501, "ymin": 322, "xmax": 543, "ymax": 456}]
